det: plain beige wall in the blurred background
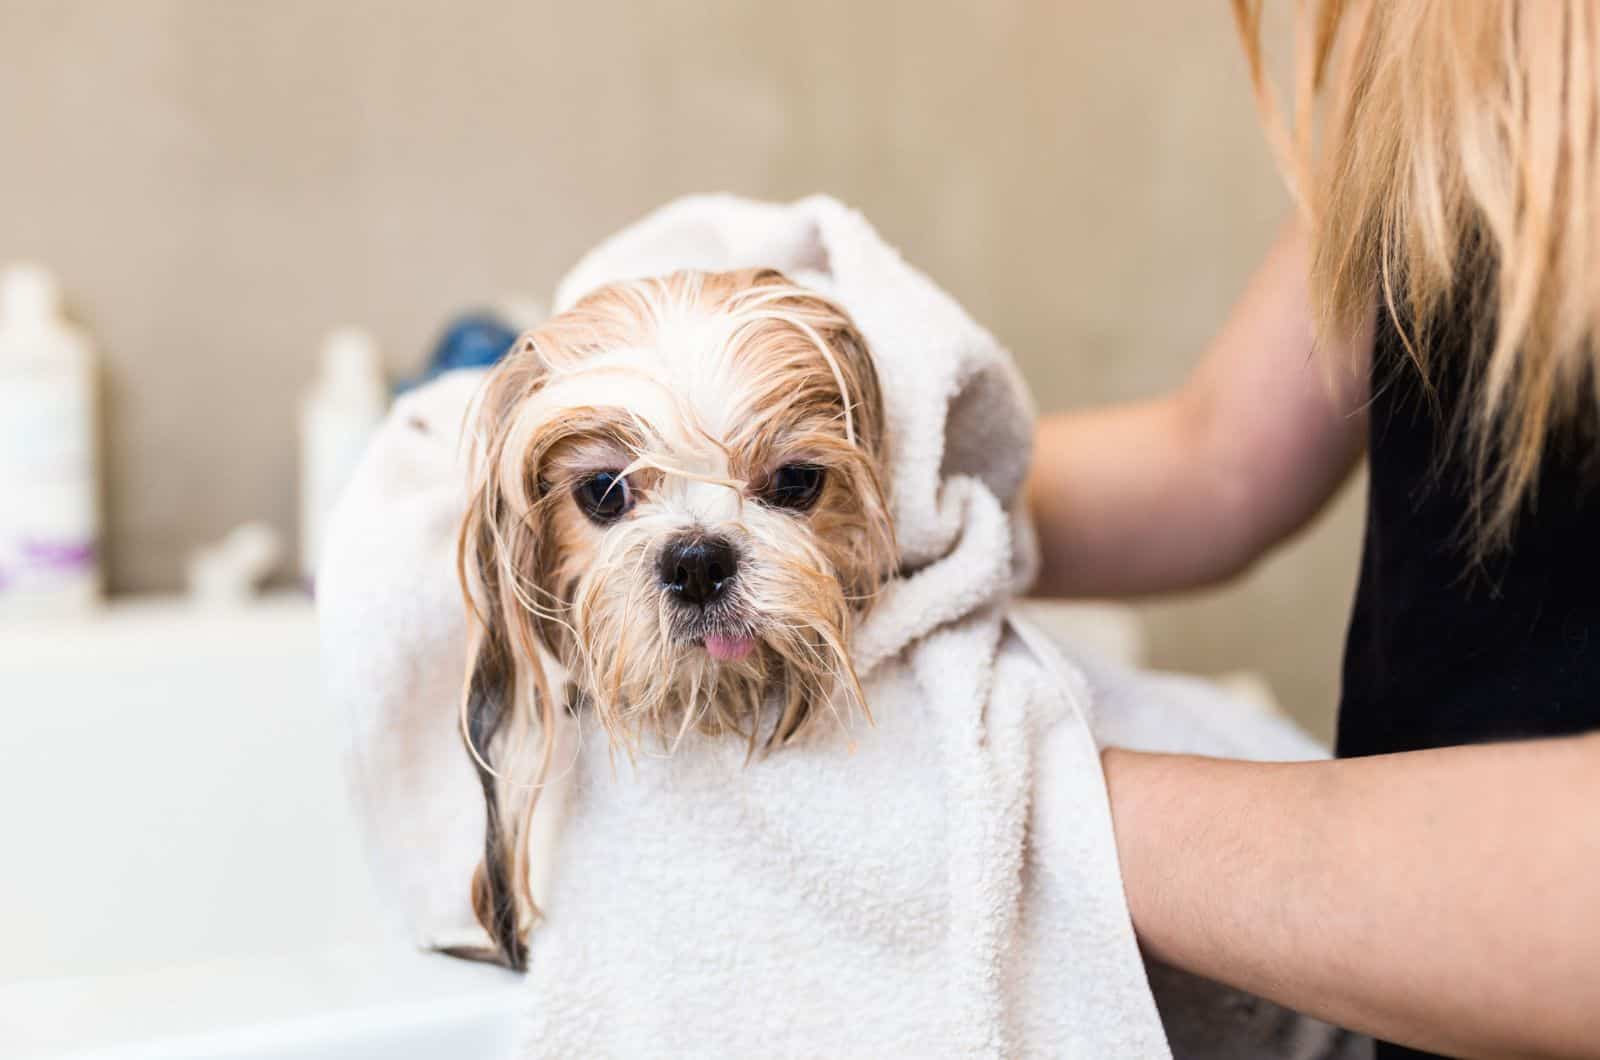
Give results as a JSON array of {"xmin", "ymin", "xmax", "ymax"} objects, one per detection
[{"xmin": 0, "ymin": 0, "xmax": 1358, "ymax": 730}]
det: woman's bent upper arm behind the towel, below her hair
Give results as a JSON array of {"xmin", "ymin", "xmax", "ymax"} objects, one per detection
[{"xmin": 1029, "ymin": 217, "xmax": 1371, "ymax": 596}]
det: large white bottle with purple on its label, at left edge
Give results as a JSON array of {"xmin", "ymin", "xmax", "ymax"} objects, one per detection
[{"xmin": 0, "ymin": 264, "xmax": 101, "ymax": 620}]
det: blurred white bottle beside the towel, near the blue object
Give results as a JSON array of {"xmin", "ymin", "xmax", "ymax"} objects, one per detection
[{"xmin": 301, "ymin": 328, "xmax": 389, "ymax": 584}]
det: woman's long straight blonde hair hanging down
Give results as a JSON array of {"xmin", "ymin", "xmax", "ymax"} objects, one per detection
[{"xmin": 1232, "ymin": 0, "xmax": 1600, "ymax": 548}]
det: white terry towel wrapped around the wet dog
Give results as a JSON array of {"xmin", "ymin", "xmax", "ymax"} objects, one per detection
[{"xmin": 318, "ymin": 197, "xmax": 1365, "ymax": 1060}]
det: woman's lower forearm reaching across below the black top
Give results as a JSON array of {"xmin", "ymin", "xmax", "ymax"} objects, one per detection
[{"xmin": 1104, "ymin": 735, "xmax": 1600, "ymax": 1057}]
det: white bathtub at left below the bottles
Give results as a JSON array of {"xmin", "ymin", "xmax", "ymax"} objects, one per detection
[{"xmin": 0, "ymin": 597, "xmax": 525, "ymax": 1060}]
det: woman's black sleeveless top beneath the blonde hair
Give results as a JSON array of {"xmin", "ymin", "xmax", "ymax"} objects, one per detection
[{"xmin": 1338, "ymin": 302, "xmax": 1600, "ymax": 1060}]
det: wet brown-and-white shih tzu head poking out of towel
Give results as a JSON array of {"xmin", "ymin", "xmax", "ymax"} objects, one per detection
[{"xmin": 459, "ymin": 269, "xmax": 896, "ymax": 969}]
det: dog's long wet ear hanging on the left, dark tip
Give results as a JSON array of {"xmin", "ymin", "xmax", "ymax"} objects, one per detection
[{"xmin": 450, "ymin": 336, "xmax": 555, "ymax": 970}]
